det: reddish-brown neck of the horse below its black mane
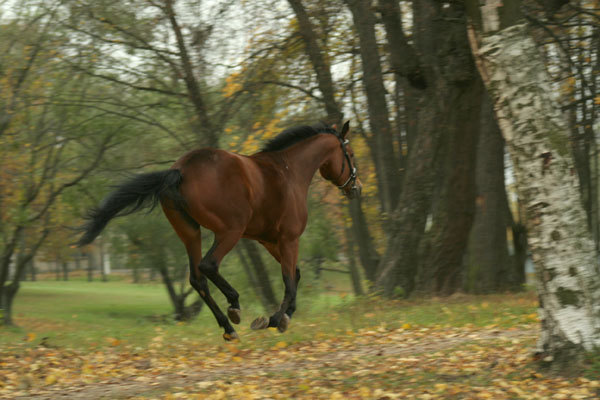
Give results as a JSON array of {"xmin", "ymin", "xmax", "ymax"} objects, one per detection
[{"xmin": 285, "ymin": 134, "xmax": 337, "ymax": 187}]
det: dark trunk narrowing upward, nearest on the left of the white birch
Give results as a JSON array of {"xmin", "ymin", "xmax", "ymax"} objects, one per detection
[{"xmin": 464, "ymin": 94, "xmax": 512, "ymax": 293}]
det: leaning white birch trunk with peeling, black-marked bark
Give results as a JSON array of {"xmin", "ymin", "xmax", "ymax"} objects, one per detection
[{"xmin": 472, "ymin": 20, "xmax": 600, "ymax": 361}]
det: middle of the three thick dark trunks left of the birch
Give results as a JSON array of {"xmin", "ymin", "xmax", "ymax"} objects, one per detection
[{"xmin": 419, "ymin": 77, "xmax": 483, "ymax": 295}]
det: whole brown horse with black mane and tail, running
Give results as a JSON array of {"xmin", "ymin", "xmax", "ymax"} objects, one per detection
[{"xmin": 78, "ymin": 121, "xmax": 362, "ymax": 340}]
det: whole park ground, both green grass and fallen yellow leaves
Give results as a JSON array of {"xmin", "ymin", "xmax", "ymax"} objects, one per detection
[{"xmin": 0, "ymin": 281, "xmax": 600, "ymax": 399}]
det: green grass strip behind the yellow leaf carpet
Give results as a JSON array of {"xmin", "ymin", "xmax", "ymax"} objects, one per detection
[{"xmin": 0, "ymin": 280, "xmax": 536, "ymax": 351}]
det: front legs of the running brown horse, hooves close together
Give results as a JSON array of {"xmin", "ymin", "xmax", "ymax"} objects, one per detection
[{"xmin": 251, "ymin": 239, "xmax": 300, "ymax": 332}]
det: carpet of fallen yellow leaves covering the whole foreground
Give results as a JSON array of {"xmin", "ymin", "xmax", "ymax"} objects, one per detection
[{"xmin": 0, "ymin": 323, "xmax": 600, "ymax": 399}]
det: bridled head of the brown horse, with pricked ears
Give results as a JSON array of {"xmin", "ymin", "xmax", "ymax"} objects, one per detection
[{"xmin": 320, "ymin": 121, "xmax": 362, "ymax": 199}]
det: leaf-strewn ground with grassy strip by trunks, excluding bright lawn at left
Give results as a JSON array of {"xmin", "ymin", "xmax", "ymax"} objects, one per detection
[{"xmin": 0, "ymin": 280, "xmax": 600, "ymax": 399}]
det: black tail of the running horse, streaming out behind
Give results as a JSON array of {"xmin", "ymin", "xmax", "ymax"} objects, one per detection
[{"xmin": 77, "ymin": 169, "xmax": 185, "ymax": 246}]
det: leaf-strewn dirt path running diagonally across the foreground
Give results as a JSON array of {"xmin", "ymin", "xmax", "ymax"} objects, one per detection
[{"xmin": 17, "ymin": 329, "xmax": 537, "ymax": 399}]
